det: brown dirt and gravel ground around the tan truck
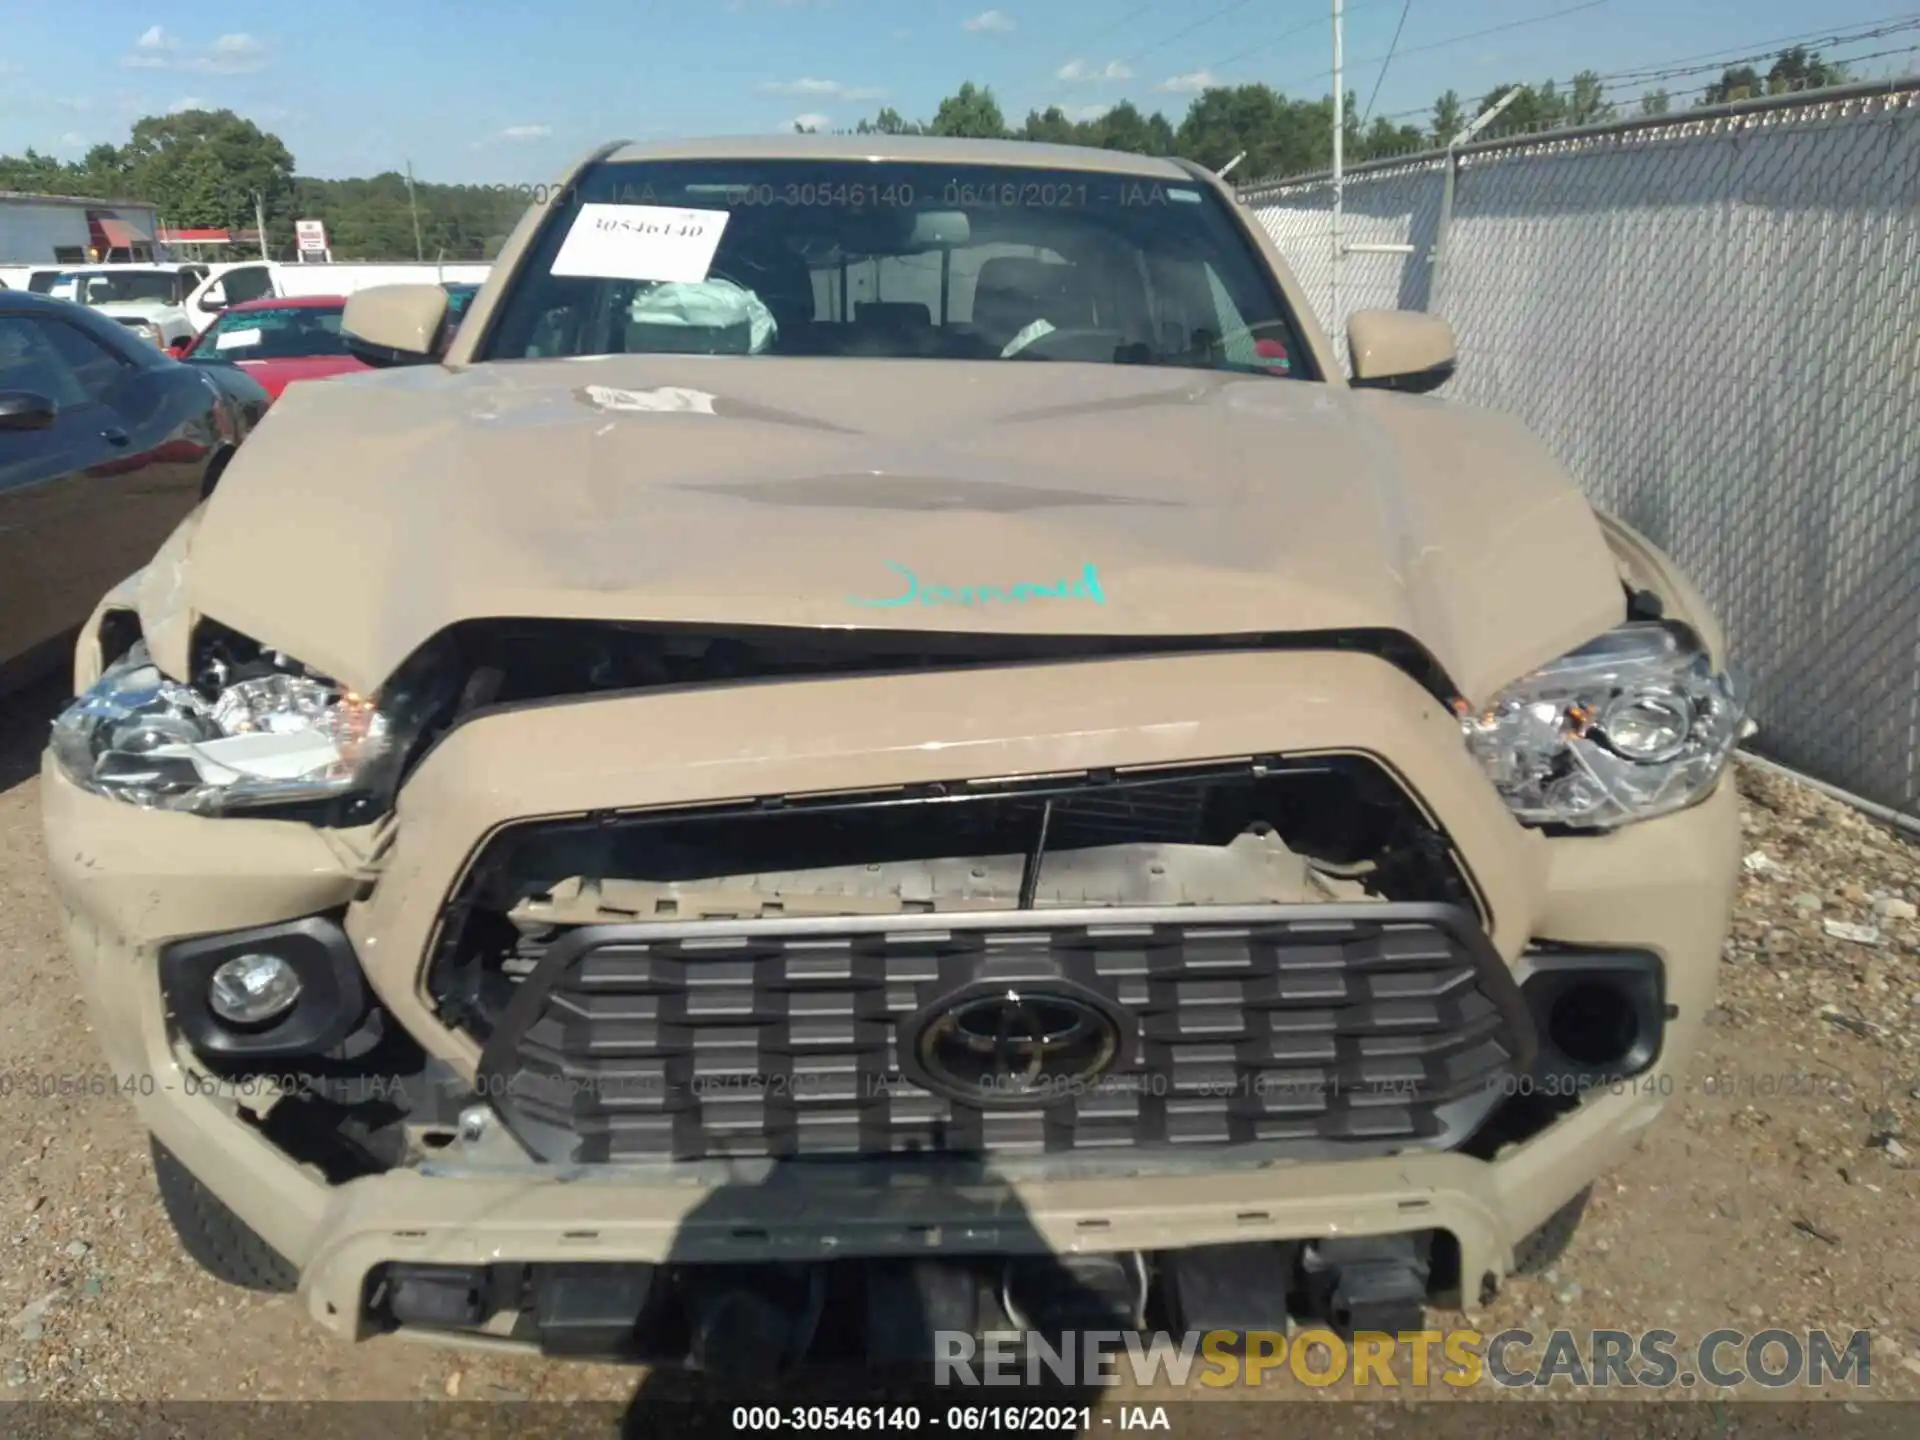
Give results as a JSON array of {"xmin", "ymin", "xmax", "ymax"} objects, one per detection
[{"xmin": 0, "ymin": 687, "xmax": 1920, "ymax": 1434}]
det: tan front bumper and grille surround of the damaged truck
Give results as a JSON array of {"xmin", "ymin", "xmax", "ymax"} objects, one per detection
[{"xmin": 42, "ymin": 655, "xmax": 1738, "ymax": 1336}]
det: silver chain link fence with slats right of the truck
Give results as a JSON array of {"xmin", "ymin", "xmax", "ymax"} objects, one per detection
[{"xmin": 1242, "ymin": 79, "xmax": 1920, "ymax": 816}]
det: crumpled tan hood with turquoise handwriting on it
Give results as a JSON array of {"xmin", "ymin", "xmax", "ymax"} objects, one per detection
[{"xmin": 182, "ymin": 355, "xmax": 1622, "ymax": 699}]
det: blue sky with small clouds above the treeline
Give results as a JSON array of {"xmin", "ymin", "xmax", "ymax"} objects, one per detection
[{"xmin": 0, "ymin": 0, "xmax": 1920, "ymax": 184}]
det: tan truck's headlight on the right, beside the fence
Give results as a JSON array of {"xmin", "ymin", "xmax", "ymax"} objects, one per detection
[{"xmin": 1461, "ymin": 622, "xmax": 1745, "ymax": 829}]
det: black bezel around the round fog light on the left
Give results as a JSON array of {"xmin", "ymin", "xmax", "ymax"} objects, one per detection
[{"xmin": 159, "ymin": 916, "xmax": 369, "ymax": 1060}]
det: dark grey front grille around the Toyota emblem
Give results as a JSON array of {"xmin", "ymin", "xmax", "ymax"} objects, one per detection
[{"xmin": 480, "ymin": 902, "xmax": 1532, "ymax": 1162}]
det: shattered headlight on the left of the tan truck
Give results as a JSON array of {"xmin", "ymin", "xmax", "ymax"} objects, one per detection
[{"xmin": 52, "ymin": 641, "xmax": 396, "ymax": 814}]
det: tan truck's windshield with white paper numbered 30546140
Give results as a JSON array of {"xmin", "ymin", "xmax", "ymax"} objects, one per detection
[{"xmin": 480, "ymin": 159, "xmax": 1311, "ymax": 376}]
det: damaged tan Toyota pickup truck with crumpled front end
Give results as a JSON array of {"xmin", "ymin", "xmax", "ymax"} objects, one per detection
[{"xmin": 44, "ymin": 136, "xmax": 1743, "ymax": 1373}]
